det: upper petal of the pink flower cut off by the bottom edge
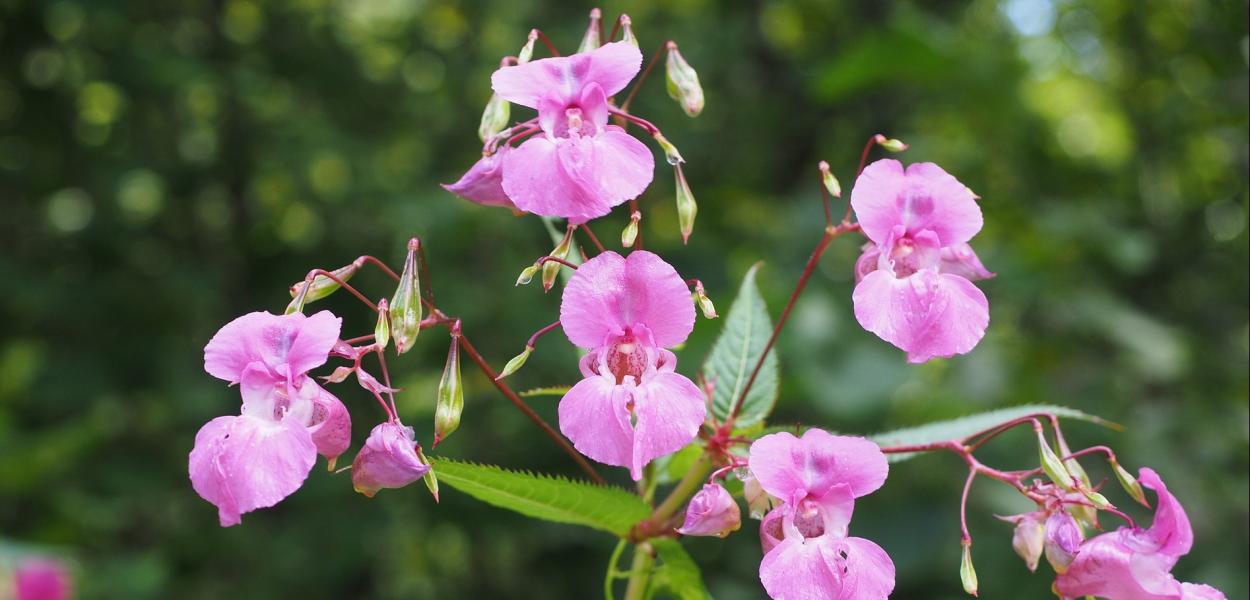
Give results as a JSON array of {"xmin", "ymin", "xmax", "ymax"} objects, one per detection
[{"xmin": 750, "ymin": 429, "xmax": 889, "ymax": 505}]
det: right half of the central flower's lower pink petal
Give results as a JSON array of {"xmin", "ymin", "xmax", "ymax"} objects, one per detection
[{"xmin": 630, "ymin": 373, "xmax": 708, "ymax": 481}]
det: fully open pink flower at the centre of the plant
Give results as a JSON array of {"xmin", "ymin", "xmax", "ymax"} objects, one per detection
[{"xmin": 560, "ymin": 250, "xmax": 706, "ymax": 480}]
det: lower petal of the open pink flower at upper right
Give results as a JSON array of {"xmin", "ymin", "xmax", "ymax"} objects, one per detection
[{"xmin": 853, "ymin": 270, "xmax": 990, "ymax": 363}]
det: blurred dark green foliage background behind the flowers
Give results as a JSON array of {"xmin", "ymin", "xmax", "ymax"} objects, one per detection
[{"xmin": 0, "ymin": 0, "xmax": 1250, "ymax": 599}]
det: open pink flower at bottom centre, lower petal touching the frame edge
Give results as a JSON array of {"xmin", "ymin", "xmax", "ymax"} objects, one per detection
[{"xmin": 750, "ymin": 429, "xmax": 894, "ymax": 600}]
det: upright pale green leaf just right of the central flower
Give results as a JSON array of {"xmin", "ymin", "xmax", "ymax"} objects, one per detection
[{"xmin": 704, "ymin": 263, "xmax": 778, "ymax": 428}]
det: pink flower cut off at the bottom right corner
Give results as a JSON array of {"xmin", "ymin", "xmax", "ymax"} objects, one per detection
[{"xmin": 1055, "ymin": 469, "xmax": 1225, "ymax": 600}]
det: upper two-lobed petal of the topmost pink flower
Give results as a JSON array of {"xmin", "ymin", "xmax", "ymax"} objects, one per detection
[{"xmin": 490, "ymin": 41, "xmax": 643, "ymax": 109}]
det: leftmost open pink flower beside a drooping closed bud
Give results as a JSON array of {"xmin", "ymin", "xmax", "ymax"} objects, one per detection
[{"xmin": 189, "ymin": 311, "xmax": 351, "ymax": 526}]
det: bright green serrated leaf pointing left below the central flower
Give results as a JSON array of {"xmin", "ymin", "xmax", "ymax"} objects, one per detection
[{"xmin": 433, "ymin": 458, "xmax": 651, "ymax": 538}]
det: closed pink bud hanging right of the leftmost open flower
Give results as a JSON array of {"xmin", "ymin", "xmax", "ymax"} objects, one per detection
[{"xmin": 351, "ymin": 423, "xmax": 430, "ymax": 498}]
